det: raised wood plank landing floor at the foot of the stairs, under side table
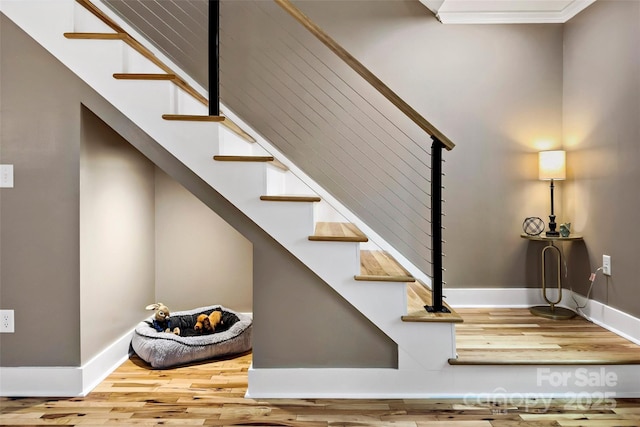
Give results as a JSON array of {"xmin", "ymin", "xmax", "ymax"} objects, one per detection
[{"xmin": 456, "ymin": 308, "xmax": 640, "ymax": 370}]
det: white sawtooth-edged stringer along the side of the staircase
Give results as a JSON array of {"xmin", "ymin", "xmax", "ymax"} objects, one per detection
[{"xmin": 0, "ymin": 0, "xmax": 455, "ymax": 394}]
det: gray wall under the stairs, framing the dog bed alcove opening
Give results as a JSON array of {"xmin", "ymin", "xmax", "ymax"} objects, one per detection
[{"xmin": 0, "ymin": 15, "xmax": 397, "ymax": 367}]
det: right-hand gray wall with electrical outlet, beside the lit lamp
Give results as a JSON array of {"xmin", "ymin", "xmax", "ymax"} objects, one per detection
[{"xmin": 564, "ymin": 1, "xmax": 640, "ymax": 317}]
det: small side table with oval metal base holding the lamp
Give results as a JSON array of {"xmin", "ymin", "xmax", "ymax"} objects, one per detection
[{"xmin": 520, "ymin": 234, "xmax": 584, "ymax": 320}]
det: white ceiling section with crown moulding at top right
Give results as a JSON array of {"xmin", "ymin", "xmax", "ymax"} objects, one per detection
[{"xmin": 420, "ymin": 0, "xmax": 596, "ymax": 24}]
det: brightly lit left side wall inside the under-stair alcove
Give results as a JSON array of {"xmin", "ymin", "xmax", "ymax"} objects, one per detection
[{"xmin": 76, "ymin": 107, "xmax": 156, "ymax": 364}]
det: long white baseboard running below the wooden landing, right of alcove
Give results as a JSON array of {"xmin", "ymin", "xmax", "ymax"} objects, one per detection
[{"xmin": 246, "ymin": 365, "xmax": 640, "ymax": 398}]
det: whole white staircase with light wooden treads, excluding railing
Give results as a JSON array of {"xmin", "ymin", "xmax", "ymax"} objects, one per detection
[{"xmin": 0, "ymin": 0, "xmax": 461, "ymax": 395}]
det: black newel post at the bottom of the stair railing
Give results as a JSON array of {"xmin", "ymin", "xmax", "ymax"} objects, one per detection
[{"xmin": 424, "ymin": 136, "xmax": 449, "ymax": 313}]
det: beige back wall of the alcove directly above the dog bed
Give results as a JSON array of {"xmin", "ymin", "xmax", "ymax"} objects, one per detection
[{"xmin": 155, "ymin": 168, "xmax": 253, "ymax": 312}]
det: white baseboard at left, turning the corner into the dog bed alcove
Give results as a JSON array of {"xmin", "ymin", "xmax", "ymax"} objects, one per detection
[{"xmin": 0, "ymin": 330, "xmax": 133, "ymax": 397}]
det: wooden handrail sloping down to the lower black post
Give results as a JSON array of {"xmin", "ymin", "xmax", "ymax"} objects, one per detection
[{"xmin": 274, "ymin": 0, "xmax": 455, "ymax": 150}]
